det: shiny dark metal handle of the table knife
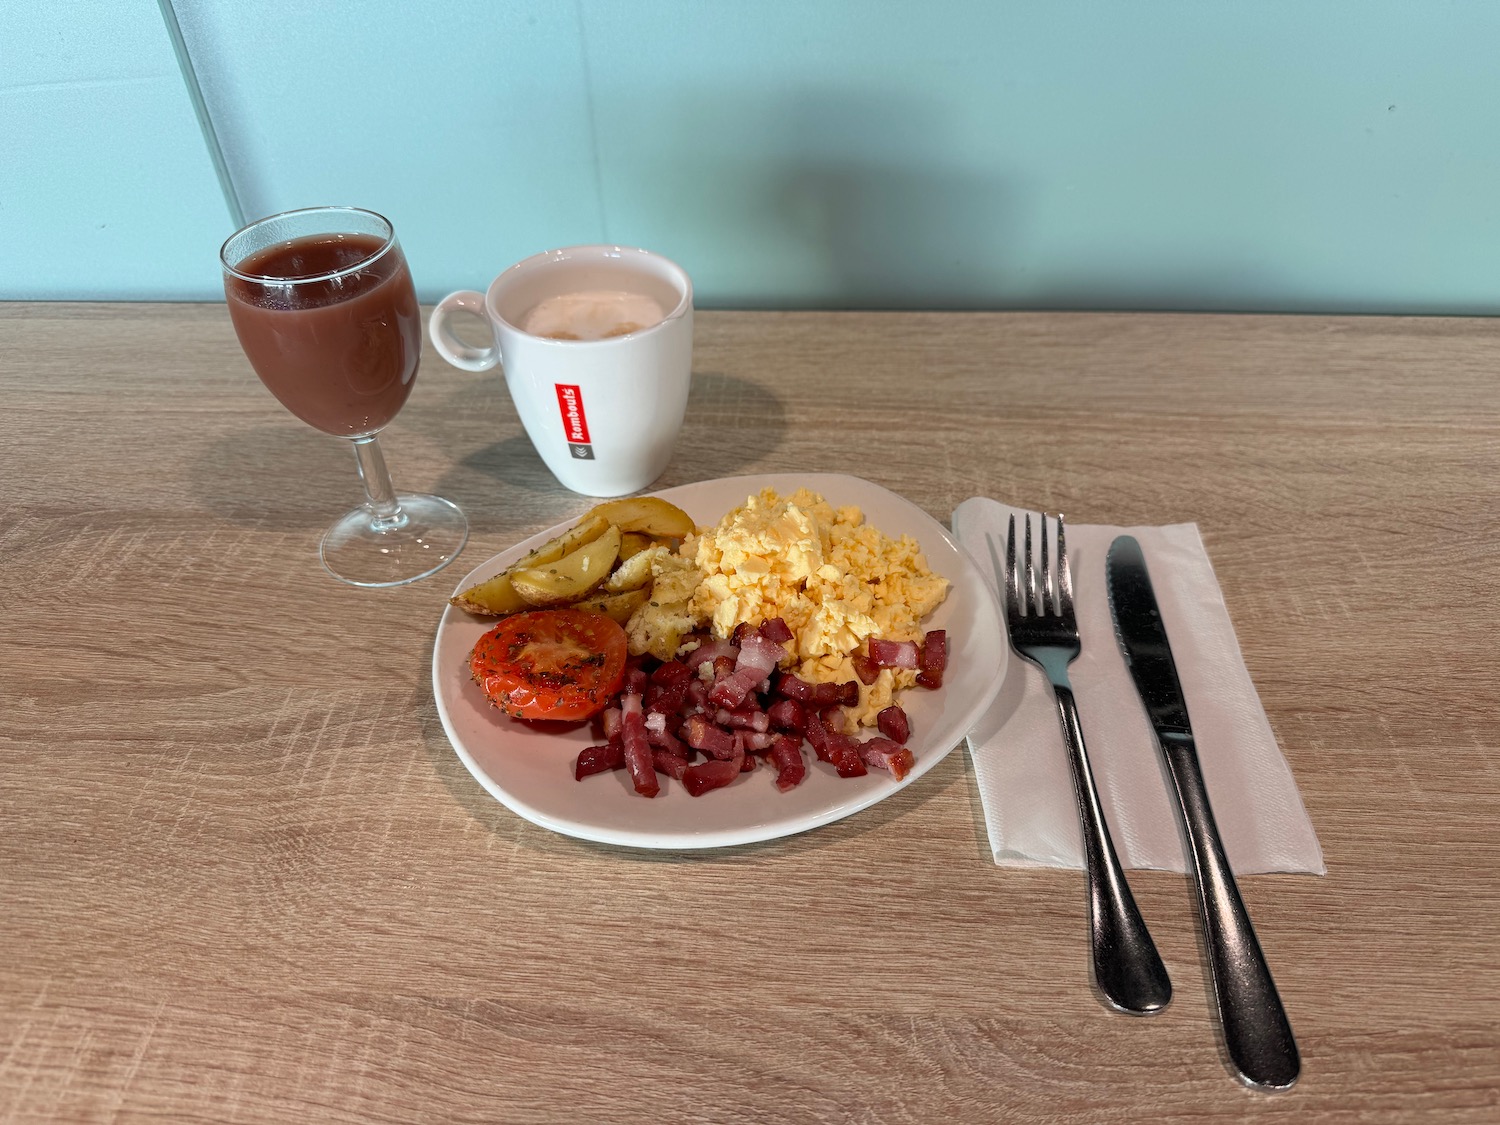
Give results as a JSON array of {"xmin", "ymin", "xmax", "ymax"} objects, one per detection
[{"xmin": 1158, "ymin": 735, "xmax": 1302, "ymax": 1089}]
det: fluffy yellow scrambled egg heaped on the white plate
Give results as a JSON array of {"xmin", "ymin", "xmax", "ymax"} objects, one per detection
[{"xmin": 683, "ymin": 489, "xmax": 948, "ymax": 726}]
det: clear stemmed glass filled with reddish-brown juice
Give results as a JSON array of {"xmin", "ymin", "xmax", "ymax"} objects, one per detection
[{"xmin": 219, "ymin": 207, "xmax": 468, "ymax": 587}]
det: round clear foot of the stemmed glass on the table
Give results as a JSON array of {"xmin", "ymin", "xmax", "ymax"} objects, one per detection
[{"xmin": 320, "ymin": 492, "xmax": 468, "ymax": 587}]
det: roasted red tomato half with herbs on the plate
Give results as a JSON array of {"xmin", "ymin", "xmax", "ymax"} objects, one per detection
[{"xmin": 470, "ymin": 609, "xmax": 626, "ymax": 723}]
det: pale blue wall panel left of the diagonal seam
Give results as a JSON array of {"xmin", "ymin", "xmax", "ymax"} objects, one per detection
[{"xmin": 0, "ymin": 0, "xmax": 227, "ymax": 300}]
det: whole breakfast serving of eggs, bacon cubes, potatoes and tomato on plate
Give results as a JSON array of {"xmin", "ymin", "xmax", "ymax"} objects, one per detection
[{"xmin": 453, "ymin": 489, "xmax": 950, "ymax": 797}]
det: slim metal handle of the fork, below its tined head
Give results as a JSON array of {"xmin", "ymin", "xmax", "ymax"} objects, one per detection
[{"xmin": 1053, "ymin": 681, "xmax": 1172, "ymax": 1016}]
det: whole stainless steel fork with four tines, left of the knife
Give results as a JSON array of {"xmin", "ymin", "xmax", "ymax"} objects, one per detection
[{"xmin": 1005, "ymin": 513, "xmax": 1172, "ymax": 1016}]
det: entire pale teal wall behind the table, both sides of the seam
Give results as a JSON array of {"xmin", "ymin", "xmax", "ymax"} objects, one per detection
[{"xmin": 0, "ymin": 0, "xmax": 1500, "ymax": 314}]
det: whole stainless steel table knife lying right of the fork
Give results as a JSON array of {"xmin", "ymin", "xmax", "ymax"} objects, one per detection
[{"xmin": 1106, "ymin": 536, "xmax": 1302, "ymax": 1089}]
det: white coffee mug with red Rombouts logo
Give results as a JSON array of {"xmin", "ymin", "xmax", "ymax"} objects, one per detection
[{"xmin": 428, "ymin": 246, "xmax": 693, "ymax": 497}]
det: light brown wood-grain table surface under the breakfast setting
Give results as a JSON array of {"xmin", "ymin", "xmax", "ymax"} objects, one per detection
[{"xmin": 0, "ymin": 305, "xmax": 1500, "ymax": 1124}]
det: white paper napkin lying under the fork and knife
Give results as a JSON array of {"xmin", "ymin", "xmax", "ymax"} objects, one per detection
[{"xmin": 953, "ymin": 497, "xmax": 1326, "ymax": 875}]
